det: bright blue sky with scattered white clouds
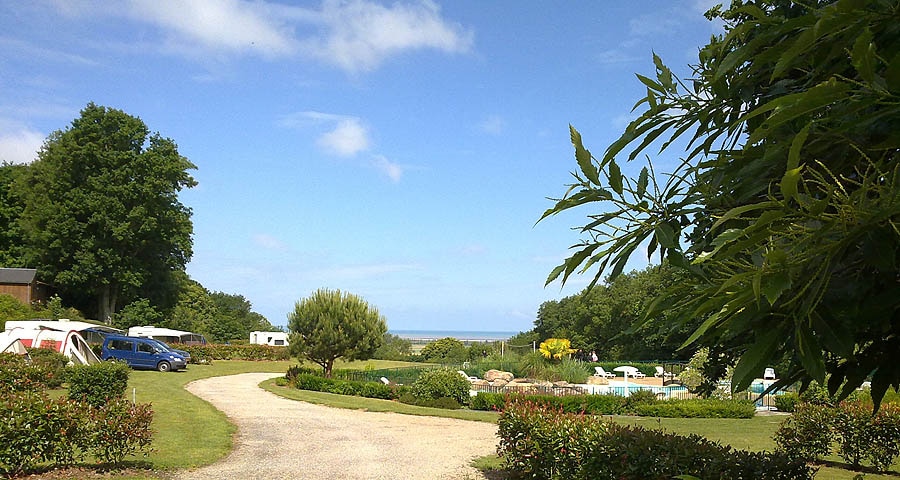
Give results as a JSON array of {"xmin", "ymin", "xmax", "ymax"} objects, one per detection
[{"xmin": 0, "ymin": 0, "xmax": 721, "ymax": 331}]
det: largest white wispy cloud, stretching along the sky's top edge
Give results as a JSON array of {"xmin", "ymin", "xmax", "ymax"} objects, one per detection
[{"xmin": 46, "ymin": 0, "xmax": 474, "ymax": 73}]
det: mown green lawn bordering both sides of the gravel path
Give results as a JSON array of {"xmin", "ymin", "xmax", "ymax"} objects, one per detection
[{"xmin": 29, "ymin": 361, "xmax": 898, "ymax": 480}]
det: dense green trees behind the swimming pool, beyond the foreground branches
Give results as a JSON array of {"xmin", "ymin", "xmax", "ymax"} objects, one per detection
[{"xmin": 509, "ymin": 264, "xmax": 699, "ymax": 360}]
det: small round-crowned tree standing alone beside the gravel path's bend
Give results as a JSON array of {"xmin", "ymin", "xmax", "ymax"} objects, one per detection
[{"xmin": 288, "ymin": 289, "xmax": 387, "ymax": 377}]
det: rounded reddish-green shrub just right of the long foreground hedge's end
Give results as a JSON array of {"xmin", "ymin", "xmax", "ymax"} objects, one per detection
[{"xmin": 775, "ymin": 403, "xmax": 834, "ymax": 462}]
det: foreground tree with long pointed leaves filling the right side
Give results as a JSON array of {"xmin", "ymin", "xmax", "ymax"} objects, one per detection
[{"xmin": 545, "ymin": 0, "xmax": 900, "ymax": 408}]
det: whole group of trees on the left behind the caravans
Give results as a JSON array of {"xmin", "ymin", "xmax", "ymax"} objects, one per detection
[{"xmin": 0, "ymin": 103, "xmax": 272, "ymax": 341}]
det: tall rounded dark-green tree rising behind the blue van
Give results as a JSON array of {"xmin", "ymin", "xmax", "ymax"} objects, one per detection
[{"xmin": 18, "ymin": 103, "xmax": 196, "ymax": 320}]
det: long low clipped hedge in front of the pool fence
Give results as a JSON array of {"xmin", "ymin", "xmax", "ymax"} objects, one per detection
[{"xmin": 469, "ymin": 392, "xmax": 756, "ymax": 418}]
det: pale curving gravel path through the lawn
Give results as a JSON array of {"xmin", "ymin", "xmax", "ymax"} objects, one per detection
[{"xmin": 176, "ymin": 373, "xmax": 497, "ymax": 480}]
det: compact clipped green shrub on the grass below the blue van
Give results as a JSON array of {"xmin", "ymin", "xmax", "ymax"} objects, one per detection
[{"xmin": 66, "ymin": 362, "xmax": 131, "ymax": 407}]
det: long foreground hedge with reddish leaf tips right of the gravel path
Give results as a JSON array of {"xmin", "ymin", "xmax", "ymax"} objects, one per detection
[{"xmin": 498, "ymin": 400, "xmax": 813, "ymax": 480}]
